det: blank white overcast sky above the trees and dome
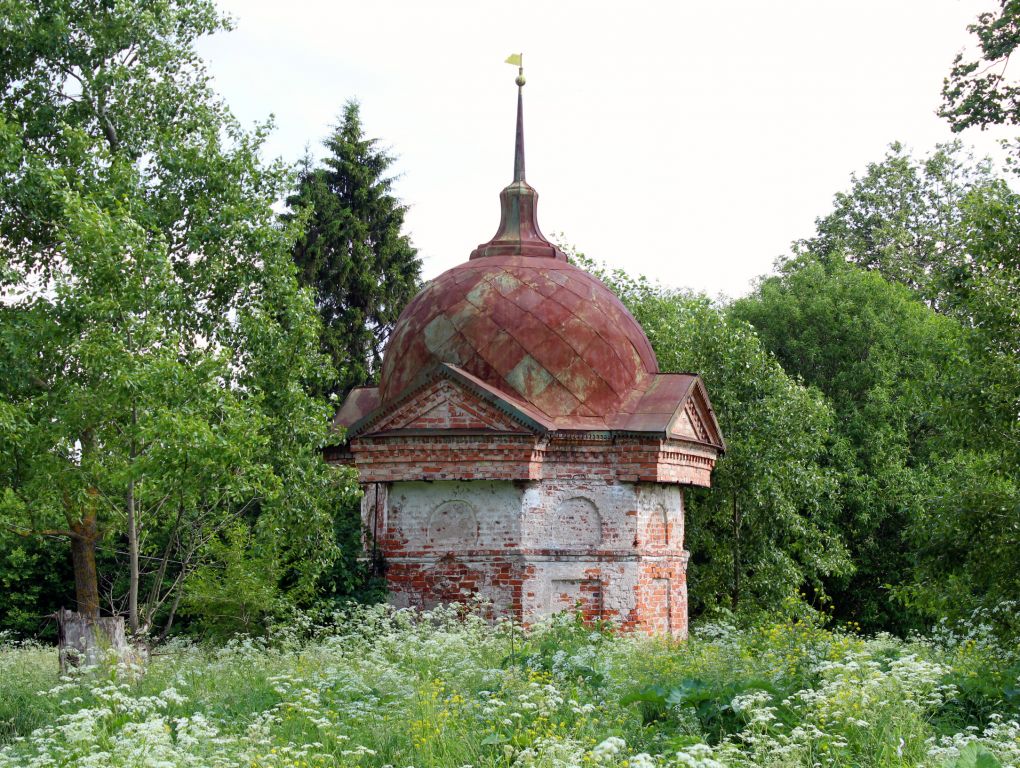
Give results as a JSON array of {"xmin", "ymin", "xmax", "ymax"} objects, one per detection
[{"xmin": 194, "ymin": 0, "xmax": 1006, "ymax": 296}]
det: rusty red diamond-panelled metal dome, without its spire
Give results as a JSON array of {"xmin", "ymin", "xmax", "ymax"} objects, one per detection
[{"xmin": 379, "ymin": 254, "xmax": 658, "ymax": 418}]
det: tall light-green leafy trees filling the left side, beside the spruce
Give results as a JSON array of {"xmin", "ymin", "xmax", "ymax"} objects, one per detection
[{"xmin": 0, "ymin": 0, "xmax": 346, "ymax": 631}]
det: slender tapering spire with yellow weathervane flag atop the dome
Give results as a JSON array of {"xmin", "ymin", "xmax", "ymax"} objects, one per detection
[{"xmin": 471, "ymin": 53, "xmax": 567, "ymax": 261}]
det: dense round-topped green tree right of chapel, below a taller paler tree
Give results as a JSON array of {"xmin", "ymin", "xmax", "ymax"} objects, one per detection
[{"xmin": 732, "ymin": 257, "xmax": 962, "ymax": 630}]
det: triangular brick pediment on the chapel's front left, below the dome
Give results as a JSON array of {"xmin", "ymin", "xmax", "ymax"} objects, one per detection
[{"xmin": 358, "ymin": 375, "xmax": 536, "ymax": 434}]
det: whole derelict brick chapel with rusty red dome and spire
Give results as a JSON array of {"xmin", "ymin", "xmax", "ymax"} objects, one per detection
[{"xmin": 334, "ymin": 64, "xmax": 724, "ymax": 636}]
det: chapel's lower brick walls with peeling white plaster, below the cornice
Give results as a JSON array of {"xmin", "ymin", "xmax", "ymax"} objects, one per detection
[{"xmin": 371, "ymin": 479, "xmax": 686, "ymax": 635}]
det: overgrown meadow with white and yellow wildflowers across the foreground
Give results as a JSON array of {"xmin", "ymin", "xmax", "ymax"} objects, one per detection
[{"xmin": 0, "ymin": 606, "xmax": 1020, "ymax": 768}]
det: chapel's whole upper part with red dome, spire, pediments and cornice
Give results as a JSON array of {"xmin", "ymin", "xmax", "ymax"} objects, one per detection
[{"xmin": 334, "ymin": 68, "xmax": 725, "ymax": 454}]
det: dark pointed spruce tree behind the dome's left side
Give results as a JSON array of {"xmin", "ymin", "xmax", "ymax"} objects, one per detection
[{"xmin": 286, "ymin": 100, "xmax": 421, "ymax": 396}]
